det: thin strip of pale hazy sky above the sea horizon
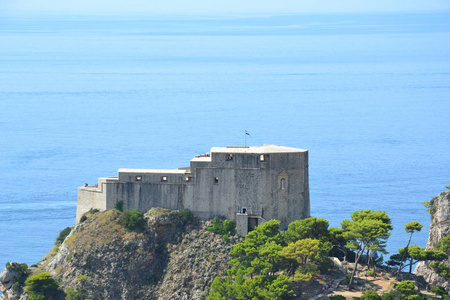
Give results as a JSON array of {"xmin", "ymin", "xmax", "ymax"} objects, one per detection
[{"xmin": 0, "ymin": 0, "xmax": 450, "ymax": 13}]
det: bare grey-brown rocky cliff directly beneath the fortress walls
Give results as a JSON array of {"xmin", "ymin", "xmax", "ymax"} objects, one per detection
[{"xmin": 1, "ymin": 209, "xmax": 237, "ymax": 300}]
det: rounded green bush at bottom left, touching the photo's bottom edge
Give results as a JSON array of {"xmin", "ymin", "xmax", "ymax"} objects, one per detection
[{"xmin": 25, "ymin": 272, "xmax": 59, "ymax": 300}]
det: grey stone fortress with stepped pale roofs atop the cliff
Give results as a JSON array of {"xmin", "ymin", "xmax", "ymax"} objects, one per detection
[{"xmin": 76, "ymin": 145, "xmax": 310, "ymax": 235}]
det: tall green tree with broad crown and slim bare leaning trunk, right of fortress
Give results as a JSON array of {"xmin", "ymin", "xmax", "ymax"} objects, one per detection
[{"xmin": 341, "ymin": 209, "xmax": 392, "ymax": 289}]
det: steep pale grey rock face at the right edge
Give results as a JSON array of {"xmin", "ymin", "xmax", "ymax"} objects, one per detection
[{"xmin": 415, "ymin": 192, "xmax": 450, "ymax": 290}]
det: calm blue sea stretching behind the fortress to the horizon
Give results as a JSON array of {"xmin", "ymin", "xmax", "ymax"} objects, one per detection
[{"xmin": 0, "ymin": 12, "xmax": 450, "ymax": 269}]
